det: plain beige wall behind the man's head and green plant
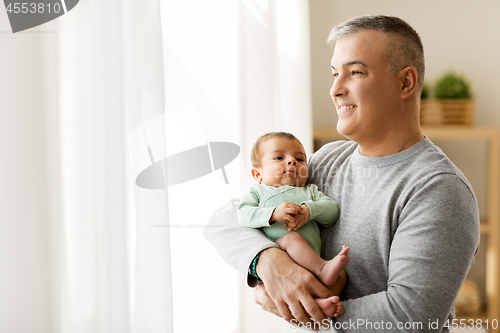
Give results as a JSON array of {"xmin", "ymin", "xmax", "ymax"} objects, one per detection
[{"xmin": 309, "ymin": 0, "xmax": 500, "ymax": 126}]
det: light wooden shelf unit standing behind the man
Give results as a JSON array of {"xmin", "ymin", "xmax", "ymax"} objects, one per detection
[{"xmin": 313, "ymin": 126, "xmax": 500, "ymax": 331}]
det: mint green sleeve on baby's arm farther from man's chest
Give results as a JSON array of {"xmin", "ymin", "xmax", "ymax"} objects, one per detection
[{"xmin": 238, "ymin": 186, "xmax": 276, "ymax": 228}]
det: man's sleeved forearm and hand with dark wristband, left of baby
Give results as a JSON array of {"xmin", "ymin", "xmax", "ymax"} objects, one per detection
[{"xmin": 204, "ymin": 200, "xmax": 331, "ymax": 323}]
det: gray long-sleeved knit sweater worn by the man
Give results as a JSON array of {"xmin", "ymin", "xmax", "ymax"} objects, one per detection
[{"xmin": 205, "ymin": 138, "xmax": 479, "ymax": 332}]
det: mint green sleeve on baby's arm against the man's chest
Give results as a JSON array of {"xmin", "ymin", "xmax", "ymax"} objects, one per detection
[{"xmin": 303, "ymin": 185, "xmax": 339, "ymax": 227}]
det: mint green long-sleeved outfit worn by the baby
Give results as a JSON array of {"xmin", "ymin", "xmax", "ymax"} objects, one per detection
[{"xmin": 238, "ymin": 184, "xmax": 339, "ymax": 255}]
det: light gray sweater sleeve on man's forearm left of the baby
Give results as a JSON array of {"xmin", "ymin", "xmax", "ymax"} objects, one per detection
[{"xmin": 203, "ymin": 199, "xmax": 278, "ymax": 287}]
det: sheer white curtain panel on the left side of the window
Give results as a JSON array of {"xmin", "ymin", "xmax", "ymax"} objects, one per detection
[{"xmin": 51, "ymin": 0, "xmax": 173, "ymax": 333}]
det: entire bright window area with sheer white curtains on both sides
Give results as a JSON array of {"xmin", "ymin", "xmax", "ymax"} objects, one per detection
[{"xmin": 50, "ymin": 0, "xmax": 312, "ymax": 333}]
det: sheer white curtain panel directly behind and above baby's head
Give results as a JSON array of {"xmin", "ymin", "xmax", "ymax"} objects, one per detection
[{"xmin": 239, "ymin": 0, "xmax": 313, "ymax": 333}]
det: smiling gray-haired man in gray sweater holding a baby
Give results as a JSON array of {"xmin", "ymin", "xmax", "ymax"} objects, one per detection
[{"xmin": 205, "ymin": 16, "xmax": 479, "ymax": 332}]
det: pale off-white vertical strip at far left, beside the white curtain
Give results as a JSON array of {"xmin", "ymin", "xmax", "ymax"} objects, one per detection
[{"xmin": 0, "ymin": 10, "xmax": 52, "ymax": 333}]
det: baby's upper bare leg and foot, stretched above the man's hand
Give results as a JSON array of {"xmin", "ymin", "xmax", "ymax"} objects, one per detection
[{"xmin": 276, "ymin": 232, "xmax": 349, "ymax": 286}]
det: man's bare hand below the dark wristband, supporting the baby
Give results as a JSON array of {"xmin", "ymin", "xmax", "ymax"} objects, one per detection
[{"xmin": 256, "ymin": 248, "xmax": 333, "ymax": 327}]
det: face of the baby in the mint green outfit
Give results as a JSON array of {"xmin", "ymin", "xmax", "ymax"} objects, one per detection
[{"xmin": 252, "ymin": 138, "xmax": 307, "ymax": 187}]
